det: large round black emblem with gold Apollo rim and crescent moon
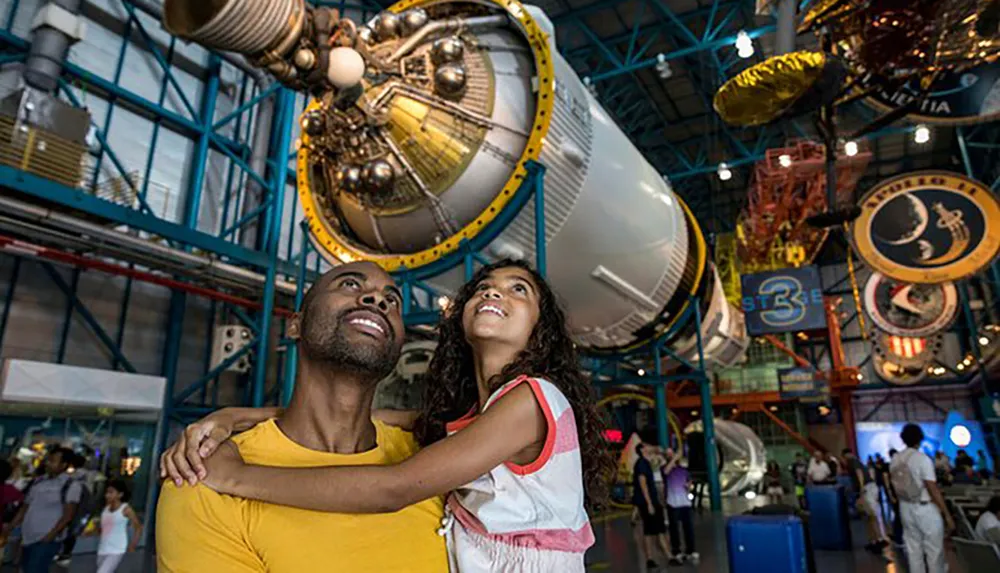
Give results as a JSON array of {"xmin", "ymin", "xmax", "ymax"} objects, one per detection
[{"xmin": 851, "ymin": 171, "xmax": 1000, "ymax": 284}]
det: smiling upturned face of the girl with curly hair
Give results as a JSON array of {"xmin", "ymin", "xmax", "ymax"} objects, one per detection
[{"xmin": 462, "ymin": 267, "xmax": 539, "ymax": 351}]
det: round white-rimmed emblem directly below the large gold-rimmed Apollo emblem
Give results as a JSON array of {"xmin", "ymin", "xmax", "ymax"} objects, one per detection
[{"xmin": 864, "ymin": 273, "xmax": 958, "ymax": 337}]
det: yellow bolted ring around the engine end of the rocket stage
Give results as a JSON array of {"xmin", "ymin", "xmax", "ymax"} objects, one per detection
[{"xmin": 297, "ymin": 0, "xmax": 555, "ymax": 271}]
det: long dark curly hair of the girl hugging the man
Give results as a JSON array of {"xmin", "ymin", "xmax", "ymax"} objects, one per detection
[{"xmin": 416, "ymin": 259, "xmax": 615, "ymax": 510}]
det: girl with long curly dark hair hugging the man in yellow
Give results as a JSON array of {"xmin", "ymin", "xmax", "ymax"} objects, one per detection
[{"xmin": 165, "ymin": 261, "xmax": 614, "ymax": 573}]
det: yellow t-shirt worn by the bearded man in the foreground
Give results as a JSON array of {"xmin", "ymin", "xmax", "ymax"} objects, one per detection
[{"xmin": 156, "ymin": 420, "xmax": 448, "ymax": 573}]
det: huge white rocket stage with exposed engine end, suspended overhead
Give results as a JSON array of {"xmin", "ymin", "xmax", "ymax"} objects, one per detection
[{"xmin": 164, "ymin": 0, "xmax": 746, "ymax": 364}]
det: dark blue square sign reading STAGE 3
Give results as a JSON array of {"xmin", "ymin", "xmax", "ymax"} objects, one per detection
[{"xmin": 740, "ymin": 266, "xmax": 826, "ymax": 336}]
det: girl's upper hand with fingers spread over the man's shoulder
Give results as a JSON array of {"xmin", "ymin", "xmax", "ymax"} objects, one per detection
[{"xmin": 160, "ymin": 409, "xmax": 236, "ymax": 487}]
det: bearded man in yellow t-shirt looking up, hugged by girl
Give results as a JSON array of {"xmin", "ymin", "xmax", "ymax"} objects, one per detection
[{"xmin": 156, "ymin": 263, "xmax": 448, "ymax": 573}]
